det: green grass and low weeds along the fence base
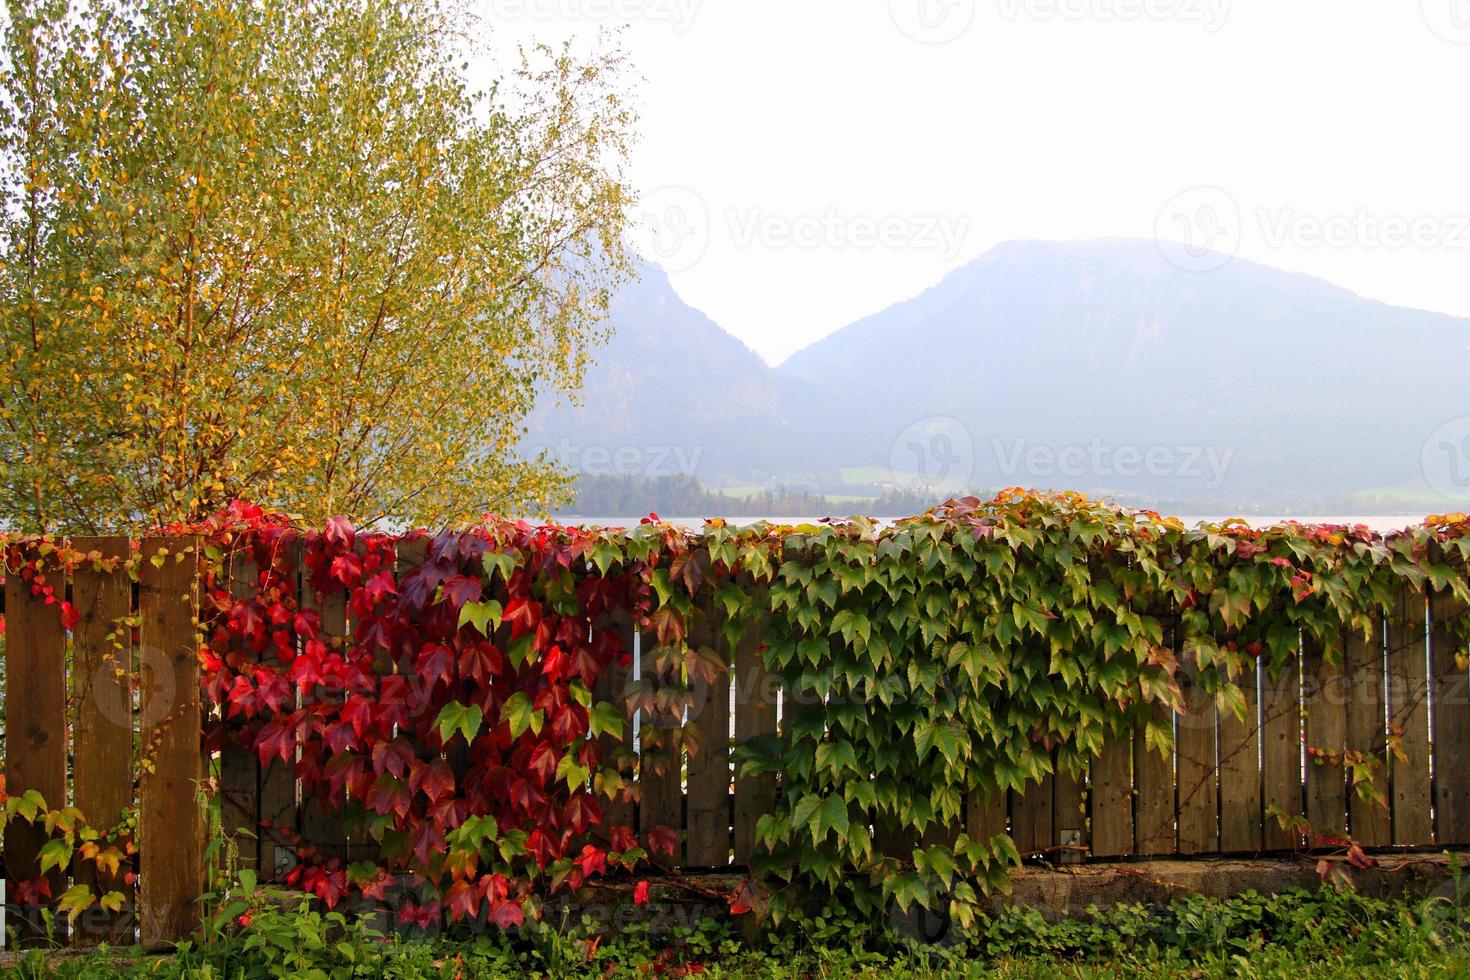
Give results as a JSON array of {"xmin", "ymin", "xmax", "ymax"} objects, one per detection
[{"xmin": 13, "ymin": 887, "xmax": 1470, "ymax": 980}]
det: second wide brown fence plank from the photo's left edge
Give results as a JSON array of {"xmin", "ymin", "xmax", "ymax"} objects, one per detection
[{"xmin": 72, "ymin": 538, "xmax": 134, "ymax": 946}]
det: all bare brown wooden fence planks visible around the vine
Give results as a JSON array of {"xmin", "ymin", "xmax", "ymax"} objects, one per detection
[{"xmin": 4, "ymin": 538, "xmax": 1470, "ymax": 943}]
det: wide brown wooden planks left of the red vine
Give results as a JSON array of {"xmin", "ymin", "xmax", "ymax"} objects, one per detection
[{"xmin": 4, "ymin": 538, "xmax": 204, "ymax": 945}]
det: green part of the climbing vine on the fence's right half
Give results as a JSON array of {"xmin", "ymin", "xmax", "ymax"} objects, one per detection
[{"xmin": 723, "ymin": 491, "xmax": 1470, "ymax": 923}]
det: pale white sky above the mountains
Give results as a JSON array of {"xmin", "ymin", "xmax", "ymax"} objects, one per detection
[{"xmin": 481, "ymin": 0, "xmax": 1470, "ymax": 363}]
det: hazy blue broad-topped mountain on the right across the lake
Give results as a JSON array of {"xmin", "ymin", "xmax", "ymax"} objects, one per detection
[{"xmin": 778, "ymin": 241, "xmax": 1470, "ymax": 502}]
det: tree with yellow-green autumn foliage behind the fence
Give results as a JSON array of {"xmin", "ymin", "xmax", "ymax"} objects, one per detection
[{"xmin": 0, "ymin": 0, "xmax": 634, "ymax": 530}]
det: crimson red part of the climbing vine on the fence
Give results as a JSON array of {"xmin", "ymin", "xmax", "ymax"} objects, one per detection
[{"xmin": 201, "ymin": 505, "xmax": 705, "ymax": 927}]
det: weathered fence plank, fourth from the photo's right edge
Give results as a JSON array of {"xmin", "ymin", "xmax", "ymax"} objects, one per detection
[{"xmin": 1302, "ymin": 636, "xmax": 1348, "ymax": 837}]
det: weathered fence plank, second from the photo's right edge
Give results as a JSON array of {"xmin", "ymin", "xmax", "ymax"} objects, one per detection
[{"xmin": 1388, "ymin": 588, "xmax": 1435, "ymax": 845}]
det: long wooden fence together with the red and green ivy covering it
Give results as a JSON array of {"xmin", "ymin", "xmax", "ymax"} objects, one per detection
[{"xmin": 4, "ymin": 491, "xmax": 1470, "ymax": 939}]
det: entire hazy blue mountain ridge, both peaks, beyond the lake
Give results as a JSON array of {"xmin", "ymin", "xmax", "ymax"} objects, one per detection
[{"xmin": 529, "ymin": 241, "xmax": 1470, "ymax": 508}]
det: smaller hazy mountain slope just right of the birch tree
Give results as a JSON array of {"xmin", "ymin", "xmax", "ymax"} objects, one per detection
[{"xmin": 525, "ymin": 266, "xmax": 788, "ymax": 482}]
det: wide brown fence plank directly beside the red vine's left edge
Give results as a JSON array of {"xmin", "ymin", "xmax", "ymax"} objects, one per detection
[{"xmin": 138, "ymin": 538, "xmax": 204, "ymax": 948}]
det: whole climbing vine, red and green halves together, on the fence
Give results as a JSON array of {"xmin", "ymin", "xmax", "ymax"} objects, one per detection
[{"xmin": 6, "ymin": 491, "xmax": 1470, "ymax": 927}]
